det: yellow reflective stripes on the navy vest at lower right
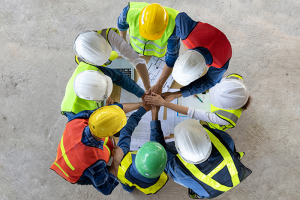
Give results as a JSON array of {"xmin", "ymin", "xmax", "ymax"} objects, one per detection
[{"xmin": 176, "ymin": 129, "xmax": 240, "ymax": 192}]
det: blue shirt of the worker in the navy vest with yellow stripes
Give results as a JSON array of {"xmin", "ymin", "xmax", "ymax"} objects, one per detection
[{"xmin": 151, "ymin": 121, "xmax": 235, "ymax": 198}]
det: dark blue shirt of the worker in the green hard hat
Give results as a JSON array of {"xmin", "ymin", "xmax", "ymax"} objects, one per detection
[{"xmin": 118, "ymin": 107, "xmax": 166, "ymax": 192}]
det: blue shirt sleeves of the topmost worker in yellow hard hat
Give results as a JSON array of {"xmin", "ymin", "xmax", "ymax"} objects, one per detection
[{"xmin": 118, "ymin": 6, "xmax": 180, "ymax": 68}]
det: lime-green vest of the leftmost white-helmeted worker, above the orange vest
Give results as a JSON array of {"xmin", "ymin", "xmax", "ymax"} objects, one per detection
[{"xmin": 61, "ymin": 62, "xmax": 103, "ymax": 114}]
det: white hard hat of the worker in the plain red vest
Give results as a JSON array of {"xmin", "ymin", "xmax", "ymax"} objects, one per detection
[{"xmin": 172, "ymin": 50, "xmax": 207, "ymax": 86}]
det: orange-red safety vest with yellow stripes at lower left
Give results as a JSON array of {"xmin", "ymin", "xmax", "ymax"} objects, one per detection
[{"xmin": 51, "ymin": 119, "xmax": 113, "ymax": 183}]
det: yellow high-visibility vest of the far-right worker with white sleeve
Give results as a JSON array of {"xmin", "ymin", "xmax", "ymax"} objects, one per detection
[{"xmin": 207, "ymin": 74, "xmax": 243, "ymax": 131}]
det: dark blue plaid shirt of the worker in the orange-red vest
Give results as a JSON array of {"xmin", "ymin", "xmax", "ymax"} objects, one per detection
[{"xmin": 68, "ymin": 104, "xmax": 123, "ymax": 195}]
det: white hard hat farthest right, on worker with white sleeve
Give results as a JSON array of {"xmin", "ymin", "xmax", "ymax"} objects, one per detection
[{"xmin": 209, "ymin": 78, "xmax": 249, "ymax": 110}]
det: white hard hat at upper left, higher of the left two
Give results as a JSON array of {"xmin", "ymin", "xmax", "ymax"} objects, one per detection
[{"xmin": 73, "ymin": 30, "xmax": 112, "ymax": 66}]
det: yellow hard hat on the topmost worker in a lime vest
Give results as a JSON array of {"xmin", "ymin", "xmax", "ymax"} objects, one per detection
[{"xmin": 139, "ymin": 3, "xmax": 169, "ymax": 40}]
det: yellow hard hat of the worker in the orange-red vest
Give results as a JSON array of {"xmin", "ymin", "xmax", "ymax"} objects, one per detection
[{"xmin": 89, "ymin": 105, "xmax": 127, "ymax": 138}]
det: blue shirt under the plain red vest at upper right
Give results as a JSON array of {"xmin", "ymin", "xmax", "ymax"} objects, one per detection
[{"xmin": 175, "ymin": 13, "xmax": 229, "ymax": 97}]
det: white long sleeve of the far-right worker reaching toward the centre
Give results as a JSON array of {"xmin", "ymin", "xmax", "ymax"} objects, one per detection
[{"xmin": 188, "ymin": 107, "xmax": 229, "ymax": 125}]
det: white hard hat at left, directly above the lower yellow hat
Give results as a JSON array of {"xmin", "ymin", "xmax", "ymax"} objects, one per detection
[{"xmin": 73, "ymin": 70, "xmax": 113, "ymax": 101}]
